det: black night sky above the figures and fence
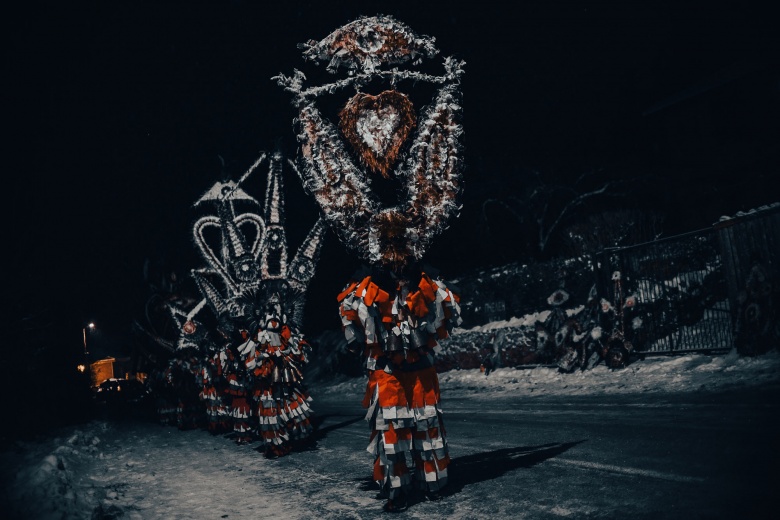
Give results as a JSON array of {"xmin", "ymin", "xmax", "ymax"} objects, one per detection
[{"xmin": 3, "ymin": 0, "xmax": 780, "ymax": 348}]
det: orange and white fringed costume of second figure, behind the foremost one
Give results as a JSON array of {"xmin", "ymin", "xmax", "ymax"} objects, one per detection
[{"xmin": 244, "ymin": 316, "xmax": 313, "ymax": 456}]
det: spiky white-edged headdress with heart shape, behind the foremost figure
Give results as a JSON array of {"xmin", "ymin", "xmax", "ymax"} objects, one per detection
[{"xmin": 171, "ymin": 152, "xmax": 326, "ymax": 346}]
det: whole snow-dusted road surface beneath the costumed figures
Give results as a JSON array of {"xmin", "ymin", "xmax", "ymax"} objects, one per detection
[{"xmin": 3, "ymin": 385, "xmax": 780, "ymax": 520}]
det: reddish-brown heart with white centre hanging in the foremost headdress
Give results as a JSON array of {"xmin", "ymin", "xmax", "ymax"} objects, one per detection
[{"xmin": 339, "ymin": 90, "xmax": 416, "ymax": 178}]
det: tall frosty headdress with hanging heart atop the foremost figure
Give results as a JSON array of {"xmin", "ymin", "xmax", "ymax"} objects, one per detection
[{"xmin": 275, "ymin": 16, "xmax": 464, "ymax": 272}]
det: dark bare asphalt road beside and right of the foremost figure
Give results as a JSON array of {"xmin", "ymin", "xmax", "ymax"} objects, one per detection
[{"xmin": 307, "ymin": 387, "xmax": 780, "ymax": 520}]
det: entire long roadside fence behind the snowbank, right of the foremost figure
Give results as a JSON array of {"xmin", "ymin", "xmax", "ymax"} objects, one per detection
[{"xmin": 451, "ymin": 203, "xmax": 780, "ymax": 365}]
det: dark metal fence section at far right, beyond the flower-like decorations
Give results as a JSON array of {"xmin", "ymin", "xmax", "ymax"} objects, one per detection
[{"xmin": 596, "ymin": 205, "xmax": 780, "ymax": 354}]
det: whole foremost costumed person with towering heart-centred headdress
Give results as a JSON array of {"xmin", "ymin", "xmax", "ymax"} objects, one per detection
[{"xmin": 275, "ymin": 16, "xmax": 464, "ymax": 511}]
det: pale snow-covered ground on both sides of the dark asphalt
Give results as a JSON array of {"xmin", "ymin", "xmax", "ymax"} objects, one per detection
[{"xmin": 0, "ymin": 351, "xmax": 780, "ymax": 519}]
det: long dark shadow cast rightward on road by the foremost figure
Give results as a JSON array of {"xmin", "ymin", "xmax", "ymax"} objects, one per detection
[{"xmin": 441, "ymin": 439, "xmax": 587, "ymax": 496}]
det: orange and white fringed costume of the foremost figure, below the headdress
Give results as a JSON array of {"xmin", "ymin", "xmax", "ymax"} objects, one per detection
[{"xmin": 338, "ymin": 273, "xmax": 461, "ymax": 499}]
